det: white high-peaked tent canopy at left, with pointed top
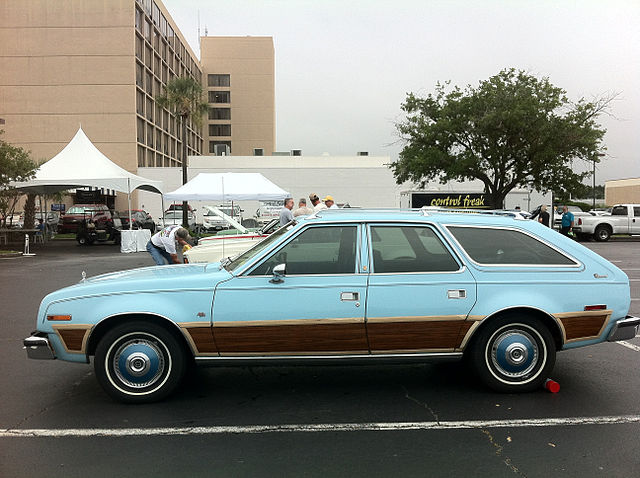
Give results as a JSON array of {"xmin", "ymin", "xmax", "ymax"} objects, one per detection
[{"xmin": 11, "ymin": 128, "xmax": 162, "ymax": 196}]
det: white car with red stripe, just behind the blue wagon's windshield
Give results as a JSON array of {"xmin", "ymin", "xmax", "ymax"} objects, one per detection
[{"xmin": 183, "ymin": 219, "xmax": 280, "ymax": 263}]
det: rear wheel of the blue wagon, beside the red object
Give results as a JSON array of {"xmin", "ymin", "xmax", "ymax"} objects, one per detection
[{"xmin": 469, "ymin": 314, "xmax": 556, "ymax": 392}]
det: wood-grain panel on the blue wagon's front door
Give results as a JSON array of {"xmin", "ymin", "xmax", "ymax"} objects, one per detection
[{"xmin": 213, "ymin": 323, "xmax": 368, "ymax": 355}]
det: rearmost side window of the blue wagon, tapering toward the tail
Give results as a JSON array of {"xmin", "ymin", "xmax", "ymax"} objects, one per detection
[{"xmin": 448, "ymin": 226, "xmax": 576, "ymax": 266}]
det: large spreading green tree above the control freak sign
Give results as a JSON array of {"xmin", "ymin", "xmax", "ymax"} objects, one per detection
[{"xmin": 391, "ymin": 69, "xmax": 613, "ymax": 208}]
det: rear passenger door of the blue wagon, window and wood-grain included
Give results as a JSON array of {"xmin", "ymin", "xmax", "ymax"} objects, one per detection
[{"xmin": 366, "ymin": 224, "xmax": 476, "ymax": 354}]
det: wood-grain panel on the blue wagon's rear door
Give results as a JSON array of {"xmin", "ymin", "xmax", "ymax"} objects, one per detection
[{"xmin": 367, "ymin": 320, "xmax": 472, "ymax": 352}]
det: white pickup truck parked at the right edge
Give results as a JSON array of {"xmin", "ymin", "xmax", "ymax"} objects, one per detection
[{"xmin": 573, "ymin": 204, "xmax": 640, "ymax": 242}]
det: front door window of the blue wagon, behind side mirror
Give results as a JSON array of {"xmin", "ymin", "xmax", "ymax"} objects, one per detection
[{"xmin": 249, "ymin": 226, "xmax": 357, "ymax": 276}]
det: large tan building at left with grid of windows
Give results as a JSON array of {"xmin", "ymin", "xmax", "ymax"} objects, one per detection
[{"xmin": 0, "ymin": 0, "xmax": 203, "ymax": 208}]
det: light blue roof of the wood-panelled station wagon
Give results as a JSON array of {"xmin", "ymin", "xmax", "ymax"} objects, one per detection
[{"xmin": 299, "ymin": 208, "xmax": 530, "ymax": 226}]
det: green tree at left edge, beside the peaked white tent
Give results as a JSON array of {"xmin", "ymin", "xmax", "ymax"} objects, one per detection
[{"xmin": 0, "ymin": 130, "xmax": 38, "ymax": 227}]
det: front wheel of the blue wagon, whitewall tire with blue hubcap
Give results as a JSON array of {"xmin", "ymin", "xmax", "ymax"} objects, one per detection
[{"xmin": 94, "ymin": 321, "xmax": 187, "ymax": 403}]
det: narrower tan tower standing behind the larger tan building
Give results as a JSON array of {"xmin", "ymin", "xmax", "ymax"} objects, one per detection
[{"xmin": 200, "ymin": 36, "xmax": 276, "ymax": 156}]
